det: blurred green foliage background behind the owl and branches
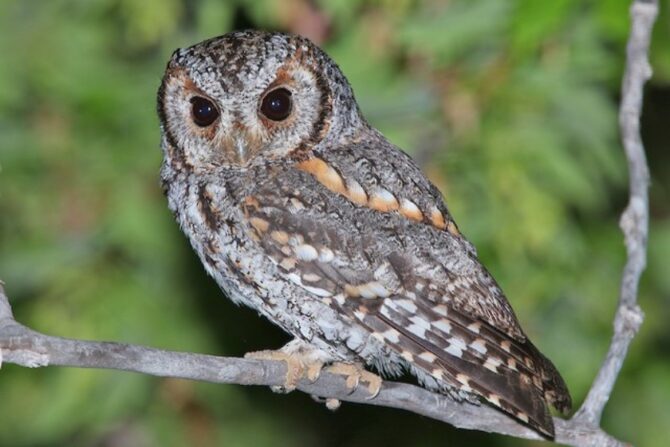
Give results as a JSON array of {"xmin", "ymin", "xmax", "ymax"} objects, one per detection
[{"xmin": 0, "ymin": 0, "xmax": 670, "ymax": 447}]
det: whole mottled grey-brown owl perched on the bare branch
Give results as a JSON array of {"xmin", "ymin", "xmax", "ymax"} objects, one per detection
[{"xmin": 158, "ymin": 31, "xmax": 571, "ymax": 437}]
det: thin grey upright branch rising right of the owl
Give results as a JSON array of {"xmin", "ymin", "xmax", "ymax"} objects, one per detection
[{"xmin": 574, "ymin": 0, "xmax": 658, "ymax": 426}]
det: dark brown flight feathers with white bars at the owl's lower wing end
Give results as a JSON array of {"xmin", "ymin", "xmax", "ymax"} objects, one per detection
[{"xmin": 364, "ymin": 300, "xmax": 570, "ymax": 438}]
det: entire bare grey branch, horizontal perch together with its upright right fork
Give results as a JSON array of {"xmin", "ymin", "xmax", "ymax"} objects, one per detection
[{"xmin": 0, "ymin": 0, "xmax": 658, "ymax": 446}]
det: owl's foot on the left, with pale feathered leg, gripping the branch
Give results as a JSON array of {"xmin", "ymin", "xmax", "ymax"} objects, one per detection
[{"xmin": 244, "ymin": 339, "xmax": 329, "ymax": 393}]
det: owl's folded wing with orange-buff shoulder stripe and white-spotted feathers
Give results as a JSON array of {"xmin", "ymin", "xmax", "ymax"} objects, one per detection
[{"xmin": 242, "ymin": 144, "xmax": 570, "ymax": 436}]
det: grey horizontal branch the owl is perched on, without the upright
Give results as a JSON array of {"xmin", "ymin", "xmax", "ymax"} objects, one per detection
[{"xmin": 0, "ymin": 285, "xmax": 623, "ymax": 446}]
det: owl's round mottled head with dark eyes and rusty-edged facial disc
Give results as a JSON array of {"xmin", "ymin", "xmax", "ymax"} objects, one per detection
[{"xmin": 158, "ymin": 31, "xmax": 365, "ymax": 166}]
